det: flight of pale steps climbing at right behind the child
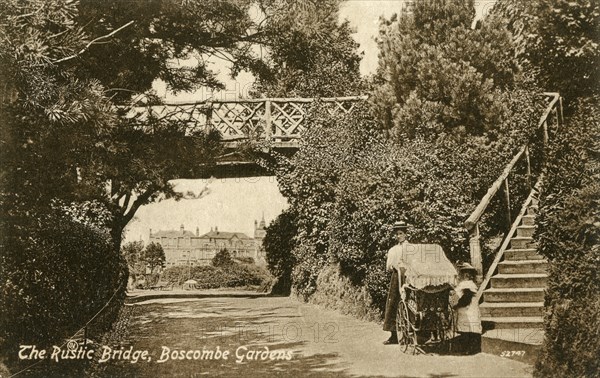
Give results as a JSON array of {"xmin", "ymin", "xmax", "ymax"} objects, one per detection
[{"xmin": 480, "ymin": 199, "xmax": 548, "ymax": 336}]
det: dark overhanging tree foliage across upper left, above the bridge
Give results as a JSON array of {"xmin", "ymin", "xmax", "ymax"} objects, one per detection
[{"xmin": 1, "ymin": 0, "xmax": 366, "ymax": 248}]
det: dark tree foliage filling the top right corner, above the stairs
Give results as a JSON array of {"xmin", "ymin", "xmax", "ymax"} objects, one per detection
[{"xmin": 493, "ymin": 0, "xmax": 600, "ymax": 102}]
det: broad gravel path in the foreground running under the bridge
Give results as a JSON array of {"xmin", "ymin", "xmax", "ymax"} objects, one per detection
[{"xmin": 97, "ymin": 297, "xmax": 532, "ymax": 377}]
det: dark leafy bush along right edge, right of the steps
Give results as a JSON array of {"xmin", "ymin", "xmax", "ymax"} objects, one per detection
[{"xmin": 536, "ymin": 97, "xmax": 600, "ymax": 377}]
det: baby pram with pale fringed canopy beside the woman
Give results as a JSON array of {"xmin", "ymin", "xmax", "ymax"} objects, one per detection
[{"xmin": 396, "ymin": 244, "xmax": 458, "ymax": 354}]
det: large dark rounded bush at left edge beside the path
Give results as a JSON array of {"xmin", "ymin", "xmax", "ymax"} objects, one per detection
[{"xmin": 0, "ymin": 210, "xmax": 127, "ymax": 356}]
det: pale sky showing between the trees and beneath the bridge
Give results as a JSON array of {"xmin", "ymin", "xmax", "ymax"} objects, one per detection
[{"xmin": 120, "ymin": 0, "xmax": 495, "ymax": 242}]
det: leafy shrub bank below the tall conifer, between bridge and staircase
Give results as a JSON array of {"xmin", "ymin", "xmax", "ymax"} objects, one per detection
[{"xmin": 276, "ymin": 91, "xmax": 539, "ymax": 308}]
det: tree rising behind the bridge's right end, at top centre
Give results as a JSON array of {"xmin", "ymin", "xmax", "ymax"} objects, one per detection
[{"xmin": 254, "ymin": 0, "xmax": 364, "ymax": 98}]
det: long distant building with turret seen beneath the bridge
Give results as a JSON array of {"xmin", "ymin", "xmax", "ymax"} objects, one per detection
[{"xmin": 150, "ymin": 216, "xmax": 266, "ymax": 267}]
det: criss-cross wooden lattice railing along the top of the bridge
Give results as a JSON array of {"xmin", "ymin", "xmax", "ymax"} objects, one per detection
[{"xmin": 132, "ymin": 96, "xmax": 367, "ymax": 146}]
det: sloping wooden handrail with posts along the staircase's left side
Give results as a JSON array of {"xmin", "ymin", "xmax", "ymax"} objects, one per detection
[{"xmin": 464, "ymin": 92, "xmax": 563, "ymax": 278}]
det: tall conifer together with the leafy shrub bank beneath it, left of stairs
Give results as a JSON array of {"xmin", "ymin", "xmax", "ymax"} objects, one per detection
[{"xmin": 267, "ymin": 0, "xmax": 540, "ymax": 309}]
